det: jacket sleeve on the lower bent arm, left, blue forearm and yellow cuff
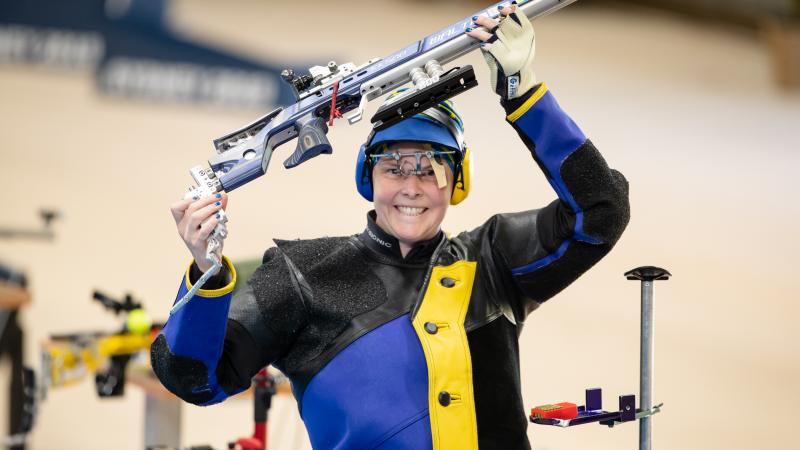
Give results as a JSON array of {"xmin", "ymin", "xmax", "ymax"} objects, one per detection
[{"xmin": 150, "ymin": 248, "xmax": 306, "ymax": 405}]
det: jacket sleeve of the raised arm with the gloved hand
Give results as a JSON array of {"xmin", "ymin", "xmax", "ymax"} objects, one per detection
[{"xmin": 468, "ymin": 84, "xmax": 630, "ymax": 320}]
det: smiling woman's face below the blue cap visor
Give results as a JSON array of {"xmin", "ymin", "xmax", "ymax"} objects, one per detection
[{"xmin": 372, "ymin": 142, "xmax": 453, "ymax": 248}]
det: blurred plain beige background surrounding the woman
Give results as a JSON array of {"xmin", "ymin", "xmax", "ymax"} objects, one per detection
[{"xmin": 0, "ymin": 0, "xmax": 800, "ymax": 450}]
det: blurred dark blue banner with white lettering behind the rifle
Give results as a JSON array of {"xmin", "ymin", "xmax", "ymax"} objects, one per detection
[{"xmin": 0, "ymin": 0, "xmax": 294, "ymax": 108}]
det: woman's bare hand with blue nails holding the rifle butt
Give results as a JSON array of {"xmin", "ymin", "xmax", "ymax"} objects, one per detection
[{"xmin": 170, "ymin": 193, "xmax": 228, "ymax": 272}]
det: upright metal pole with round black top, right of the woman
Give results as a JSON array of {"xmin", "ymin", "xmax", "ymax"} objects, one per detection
[{"xmin": 625, "ymin": 266, "xmax": 672, "ymax": 450}]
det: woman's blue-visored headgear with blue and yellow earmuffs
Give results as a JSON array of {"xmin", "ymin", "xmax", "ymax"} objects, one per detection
[{"xmin": 355, "ymin": 98, "xmax": 472, "ymax": 205}]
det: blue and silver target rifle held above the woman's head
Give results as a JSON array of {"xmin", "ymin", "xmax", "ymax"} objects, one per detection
[{"xmin": 173, "ymin": 0, "xmax": 577, "ymax": 312}]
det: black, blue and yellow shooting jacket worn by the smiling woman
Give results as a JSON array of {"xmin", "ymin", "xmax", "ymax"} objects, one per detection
[{"xmin": 152, "ymin": 84, "xmax": 629, "ymax": 450}]
